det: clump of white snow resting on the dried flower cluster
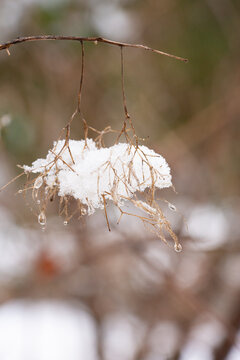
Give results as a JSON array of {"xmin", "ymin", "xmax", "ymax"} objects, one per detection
[{"xmin": 23, "ymin": 139, "xmax": 172, "ymax": 215}]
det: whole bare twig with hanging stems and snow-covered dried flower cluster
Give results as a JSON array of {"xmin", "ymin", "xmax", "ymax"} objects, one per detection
[{"xmin": 0, "ymin": 36, "xmax": 186, "ymax": 251}]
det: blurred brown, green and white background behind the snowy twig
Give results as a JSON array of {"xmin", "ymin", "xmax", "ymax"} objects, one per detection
[{"xmin": 0, "ymin": 0, "xmax": 240, "ymax": 360}]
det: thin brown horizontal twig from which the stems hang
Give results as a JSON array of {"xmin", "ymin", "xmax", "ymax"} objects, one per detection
[{"xmin": 0, "ymin": 35, "xmax": 188, "ymax": 62}]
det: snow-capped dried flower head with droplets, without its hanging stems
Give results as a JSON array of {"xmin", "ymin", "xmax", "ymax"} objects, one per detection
[{"xmin": 20, "ymin": 139, "xmax": 181, "ymax": 251}]
